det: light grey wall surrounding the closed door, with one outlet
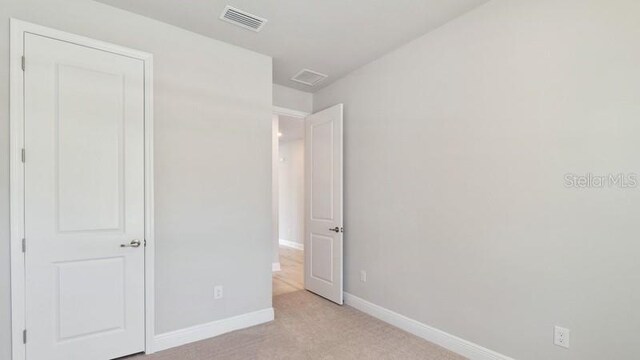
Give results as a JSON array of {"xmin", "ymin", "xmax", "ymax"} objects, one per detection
[{"xmin": 0, "ymin": 0, "xmax": 272, "ymax": 359}]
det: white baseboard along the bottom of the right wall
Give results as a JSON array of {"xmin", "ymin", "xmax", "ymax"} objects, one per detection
[{"xmin": 344, "ymin": 292, "xmax": 514, "ymax": 360}]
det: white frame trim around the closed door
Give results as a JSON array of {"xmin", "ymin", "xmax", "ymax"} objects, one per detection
[{"xmin": 9, "ymin": 18, "xmax": 155, "ymax": 360}]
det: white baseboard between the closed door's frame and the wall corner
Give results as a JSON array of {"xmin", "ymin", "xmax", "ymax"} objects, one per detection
[{"xmin": 153, "ymin": 308, "xmax": 274, "ymax": 352}]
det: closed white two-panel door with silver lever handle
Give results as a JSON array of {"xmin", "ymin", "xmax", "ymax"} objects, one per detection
[{"xmin": 24, "ymin": 33, "xmax": 145, "ymax": 360}]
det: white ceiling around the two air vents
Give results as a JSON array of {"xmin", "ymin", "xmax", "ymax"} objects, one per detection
[{"xmin": 97, "ymin": 0, "xmax": 488, "ymax": 92}]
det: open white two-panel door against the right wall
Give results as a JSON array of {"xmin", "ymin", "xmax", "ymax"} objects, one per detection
[{"xmin": 304, "ymin": 104, "xmax": 343, "ymax": 304}]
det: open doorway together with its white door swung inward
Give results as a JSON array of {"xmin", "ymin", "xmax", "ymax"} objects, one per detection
[{"xmin": 272, "ymin": 104, "xmax": 344, "ymax": 304}]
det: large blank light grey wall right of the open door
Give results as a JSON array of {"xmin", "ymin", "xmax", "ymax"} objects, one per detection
[{"xmin": 314, "ymin": 0, "xmax": 640, "ymax": 360}]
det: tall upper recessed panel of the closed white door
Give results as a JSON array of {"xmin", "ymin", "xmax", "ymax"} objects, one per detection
[{"xmin": 55, "ymin": 66, "xmax": 125, "ymax": 231}]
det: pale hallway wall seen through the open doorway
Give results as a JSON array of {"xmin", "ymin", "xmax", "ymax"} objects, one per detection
[{"xmin": 278, "ymin": 140, "xmax": 304, "ymax": 244}]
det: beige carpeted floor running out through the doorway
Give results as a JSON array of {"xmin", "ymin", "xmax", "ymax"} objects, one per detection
[{"xmin": 127, "ymin": 248, "xmax": 464, "ymax": 360}]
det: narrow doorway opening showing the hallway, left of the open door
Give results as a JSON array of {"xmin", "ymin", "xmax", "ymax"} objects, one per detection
[{"xmin": 273, "ymin": 113, "xmax": 305, "ymax": 296}]
